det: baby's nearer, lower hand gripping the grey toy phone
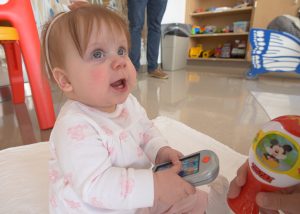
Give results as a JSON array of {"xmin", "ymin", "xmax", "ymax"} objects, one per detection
[{"xmin": 153, "ymin": 163, "xmax": 196, "ymax": 205}]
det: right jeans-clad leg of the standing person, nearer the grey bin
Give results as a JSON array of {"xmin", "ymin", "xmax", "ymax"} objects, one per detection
[{"xmin": 147, "ymin": 0, "xmax": 168, "ymax": 72}]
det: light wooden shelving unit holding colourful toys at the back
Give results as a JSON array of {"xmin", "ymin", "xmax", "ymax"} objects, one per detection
[{"xmin": 186, "ymin": 0, "xmax": 253, "ymax": 61}]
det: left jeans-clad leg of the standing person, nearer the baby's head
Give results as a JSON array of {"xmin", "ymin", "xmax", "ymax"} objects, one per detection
[{"xmin": 128, "ymin": 0, "xmax": 148, "ymax": 71}]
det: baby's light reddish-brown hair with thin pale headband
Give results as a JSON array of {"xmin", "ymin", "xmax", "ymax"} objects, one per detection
[{"xmin": 41, "ymin": 4, "xmax": 130, "ymax": 78}]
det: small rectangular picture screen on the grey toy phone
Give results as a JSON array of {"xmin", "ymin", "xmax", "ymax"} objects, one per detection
[{"xmin": 156, "ymin": 154, "xmax": 200, "ymax": 177}]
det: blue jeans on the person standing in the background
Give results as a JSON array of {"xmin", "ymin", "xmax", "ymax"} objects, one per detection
[{"xmin": 128, "ymin": 0, "xmax": 168, "ymax": 72}]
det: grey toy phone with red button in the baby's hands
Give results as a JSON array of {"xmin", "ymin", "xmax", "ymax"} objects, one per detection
[{"xmin": 153, "ymin": 150, "xmax": 219, "ymax": 186}]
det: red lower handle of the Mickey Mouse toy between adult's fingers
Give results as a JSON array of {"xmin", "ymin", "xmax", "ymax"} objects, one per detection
[{"xmin": 227, "ymin": 165, "xmax": 281, "ymax": 214}]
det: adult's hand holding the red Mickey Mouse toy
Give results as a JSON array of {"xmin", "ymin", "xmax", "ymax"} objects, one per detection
[{"xmin": 228, "ymin": 162, "xmax": 300, "ymax": 214}]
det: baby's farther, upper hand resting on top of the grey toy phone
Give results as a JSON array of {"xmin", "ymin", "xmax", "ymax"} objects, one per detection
[{"xmin": 155, "ymin": 146, "xmax": 183, "ymax": 165}]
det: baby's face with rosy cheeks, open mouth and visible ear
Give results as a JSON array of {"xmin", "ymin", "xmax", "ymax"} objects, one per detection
[{"xmin": 65, "ymin": 25, "xmax": 136, "ymax": 112}]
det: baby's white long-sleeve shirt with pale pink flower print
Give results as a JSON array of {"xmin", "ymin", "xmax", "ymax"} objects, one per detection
[{"xmin": 49, "ymin": 95, "xmax": 167, "ymax": 214}]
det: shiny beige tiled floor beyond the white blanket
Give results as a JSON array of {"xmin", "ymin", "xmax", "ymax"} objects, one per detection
[{"xmin": 0, "ymin": 66, "xmax": 300, "ymax": 154}]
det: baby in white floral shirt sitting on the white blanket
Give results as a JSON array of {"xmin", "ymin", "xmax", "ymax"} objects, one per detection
[{"xmin": 42, "ymin": 4, "xmax": 207, "ymax": 214}]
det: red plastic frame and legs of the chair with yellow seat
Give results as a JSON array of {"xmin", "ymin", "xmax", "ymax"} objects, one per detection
[{"xmin": 0, "ymin": 0, "xmax": 55, "ymax": 129}]
